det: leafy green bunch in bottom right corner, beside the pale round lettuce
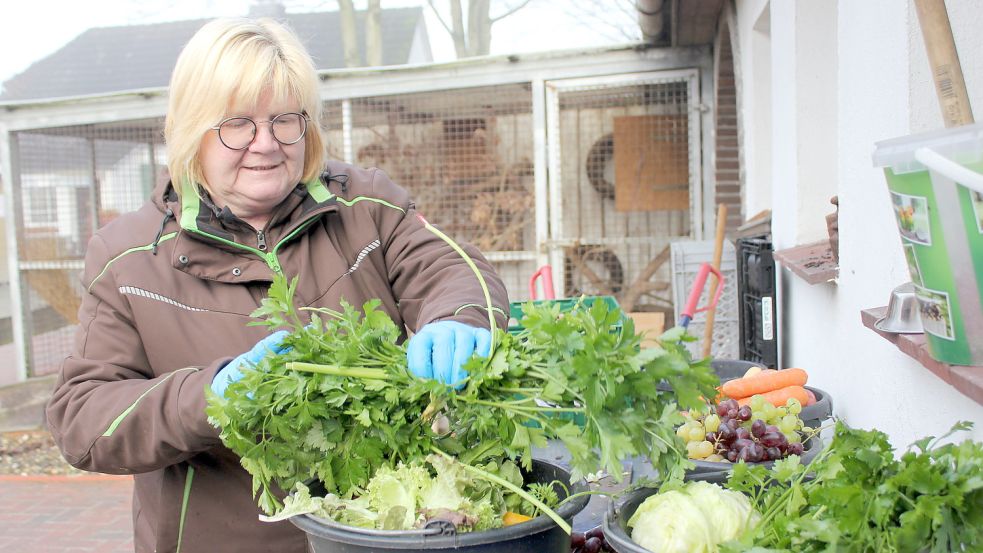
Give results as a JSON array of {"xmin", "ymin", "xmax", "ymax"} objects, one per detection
[{"xmin": 721, "ymin": 422, "xmax": 983, "ymax": 553}]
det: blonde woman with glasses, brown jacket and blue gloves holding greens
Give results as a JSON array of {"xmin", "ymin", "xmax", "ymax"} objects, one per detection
[{"xmin": 47, "ymin": 19, "xmax": 508, "ymax": 553}]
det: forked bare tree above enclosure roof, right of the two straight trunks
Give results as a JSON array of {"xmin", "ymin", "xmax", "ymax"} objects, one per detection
[{"xmin": 427, "ymin": 0, "xmax": 530, "ymax": 58}]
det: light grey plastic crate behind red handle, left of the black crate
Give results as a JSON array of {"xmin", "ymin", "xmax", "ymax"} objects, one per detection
[{"xmin": 671, "ymin": 241, "xmax": 740, "ymax": 359}]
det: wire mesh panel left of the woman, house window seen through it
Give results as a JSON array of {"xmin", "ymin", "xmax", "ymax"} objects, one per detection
[{"xmin": 12, "ymin": 119, "xmax": 164, "ymax": 375}]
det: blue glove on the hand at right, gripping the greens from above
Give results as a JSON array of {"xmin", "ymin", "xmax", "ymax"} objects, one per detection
[{"xmin": 406, "ymin": 321, "xmax": 491, "ymax": 390}]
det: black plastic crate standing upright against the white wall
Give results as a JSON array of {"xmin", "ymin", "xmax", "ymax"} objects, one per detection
[{"xmin": 737, "ymin": 237, "xmax": 778, "ymax": 369}]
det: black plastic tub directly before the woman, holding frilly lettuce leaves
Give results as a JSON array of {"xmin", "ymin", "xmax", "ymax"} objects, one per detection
[{"xmin": 290, "ymin": 459, "xmax": 590, "ymax": 553}]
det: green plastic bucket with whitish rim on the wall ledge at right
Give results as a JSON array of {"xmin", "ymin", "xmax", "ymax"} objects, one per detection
[{"xmin": 874, "ymin": 124, "xmax": 983, "ymax": 365}]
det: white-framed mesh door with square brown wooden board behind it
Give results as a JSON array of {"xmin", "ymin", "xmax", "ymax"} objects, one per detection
[{"xmin": 549, "ymin": 74, "xmax": 700, "ymax": 317}]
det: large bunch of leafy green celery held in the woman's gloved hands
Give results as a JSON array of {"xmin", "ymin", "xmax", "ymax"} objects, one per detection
[{"xmin": 206, "ymin": 277, "xmax": 718, "ymax": 513}]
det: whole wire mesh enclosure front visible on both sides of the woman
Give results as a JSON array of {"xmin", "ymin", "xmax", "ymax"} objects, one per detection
[{"xmin": 9, "ymin": 63, "xmax": 716, "ymax": 375}]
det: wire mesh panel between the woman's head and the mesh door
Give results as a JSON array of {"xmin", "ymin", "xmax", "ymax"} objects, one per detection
[{"xmin": 333, "ymin": 83, "xmax": 536, "ymax": 300}]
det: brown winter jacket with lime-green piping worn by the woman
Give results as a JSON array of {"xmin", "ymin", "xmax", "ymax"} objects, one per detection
[{"xmin": 47, "ymin": 162, "xmax": 508, "ymax": 553}]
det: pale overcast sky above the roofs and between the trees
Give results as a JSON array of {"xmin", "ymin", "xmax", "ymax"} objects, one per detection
[{"xmin": 0, "ymin": 0, "xmax": 632, "ymax": 82}]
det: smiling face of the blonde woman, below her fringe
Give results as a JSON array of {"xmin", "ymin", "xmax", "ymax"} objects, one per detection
[{"xmin": 198, "ymin": 93, "xmax": 305, "ymax": 230}]
